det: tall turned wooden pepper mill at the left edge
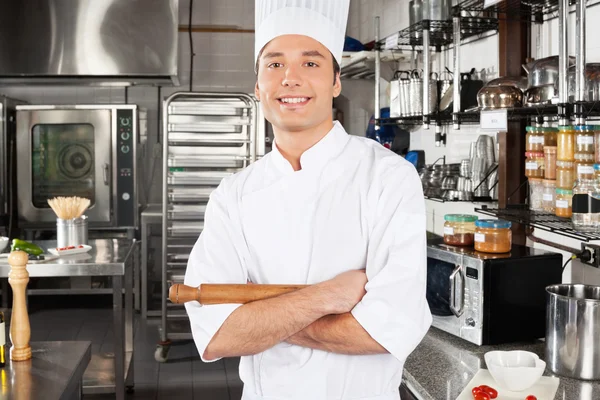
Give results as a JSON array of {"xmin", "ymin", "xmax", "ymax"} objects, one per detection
[{"xmin": 8, "ymin": 251, "xmax": 31, "ymax": 361}]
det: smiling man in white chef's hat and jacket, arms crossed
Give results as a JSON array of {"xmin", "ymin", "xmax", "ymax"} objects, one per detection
[{"xmin": 185, "ymin": 0, "xmax": 431, "ymax": 400}]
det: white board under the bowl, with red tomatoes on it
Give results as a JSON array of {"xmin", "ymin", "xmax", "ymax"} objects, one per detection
[{"xmin": 456, "ymin": 369, "xmax": 560, "ymax": 400}]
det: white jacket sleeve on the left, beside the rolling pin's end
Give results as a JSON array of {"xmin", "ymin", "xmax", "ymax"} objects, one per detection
[{"xmin": 184, "ymin": 182, "xmax": 248, "ymax": 362}]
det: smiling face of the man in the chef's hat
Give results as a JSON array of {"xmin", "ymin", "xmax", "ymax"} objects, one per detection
[{"xmin": 255, "ymin": 35, "xmax": 342, "ymax": 132}]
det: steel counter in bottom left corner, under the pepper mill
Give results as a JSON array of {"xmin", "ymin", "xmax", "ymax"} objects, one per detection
[{"xmin": 0, "ymin": 342, "xmax": 92, "ymax": 400}]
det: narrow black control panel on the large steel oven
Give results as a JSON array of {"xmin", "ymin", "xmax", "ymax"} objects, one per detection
[{"xmin": 116, "ymin": 110, "xmax": 137, "ymax": 226}]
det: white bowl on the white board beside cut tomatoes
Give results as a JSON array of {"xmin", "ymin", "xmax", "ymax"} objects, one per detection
[{"xmin": 485, "ymin": 350, "xmax": 546, "ymax": 392}]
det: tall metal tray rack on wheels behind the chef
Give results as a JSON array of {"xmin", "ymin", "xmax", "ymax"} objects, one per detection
[{"xmin": 155, "ymin": 92, "xmax": 265, "ymax": 362}]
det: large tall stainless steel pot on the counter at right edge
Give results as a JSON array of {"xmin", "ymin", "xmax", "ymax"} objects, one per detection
[{"xmin": 546, "ymin": 284, "xmax": 600, "ymax": 380}]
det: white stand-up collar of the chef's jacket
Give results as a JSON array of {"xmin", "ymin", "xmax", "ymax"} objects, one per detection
[{"xmin": 271, "ymin": 121, "xmax": 349, "ymax": 173}]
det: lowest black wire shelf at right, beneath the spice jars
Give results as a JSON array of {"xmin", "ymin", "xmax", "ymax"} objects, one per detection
[{"xmin": 475, "ymin": 204, "xmax": 600, "ymax": 242}]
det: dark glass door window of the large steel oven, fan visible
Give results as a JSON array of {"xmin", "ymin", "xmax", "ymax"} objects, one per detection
[{"xmin": 31, "ymin": 123, "xmax": 96, "ymax": 208}]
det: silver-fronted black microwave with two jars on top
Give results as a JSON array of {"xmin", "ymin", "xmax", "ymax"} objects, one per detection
[{"xmin": 427, "ymin": 238, "xmax": 562, "ymax": 345}]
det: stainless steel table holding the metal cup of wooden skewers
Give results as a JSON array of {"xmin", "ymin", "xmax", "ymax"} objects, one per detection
[{"xmin": 0, "ymin": 239, "xmax": 137, "ymax": 400}]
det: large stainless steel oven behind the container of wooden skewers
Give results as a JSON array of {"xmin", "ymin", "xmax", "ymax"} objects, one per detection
[{"xmin": 16, "ymin": 104, "xmax": 139, "ymax": 228}]
